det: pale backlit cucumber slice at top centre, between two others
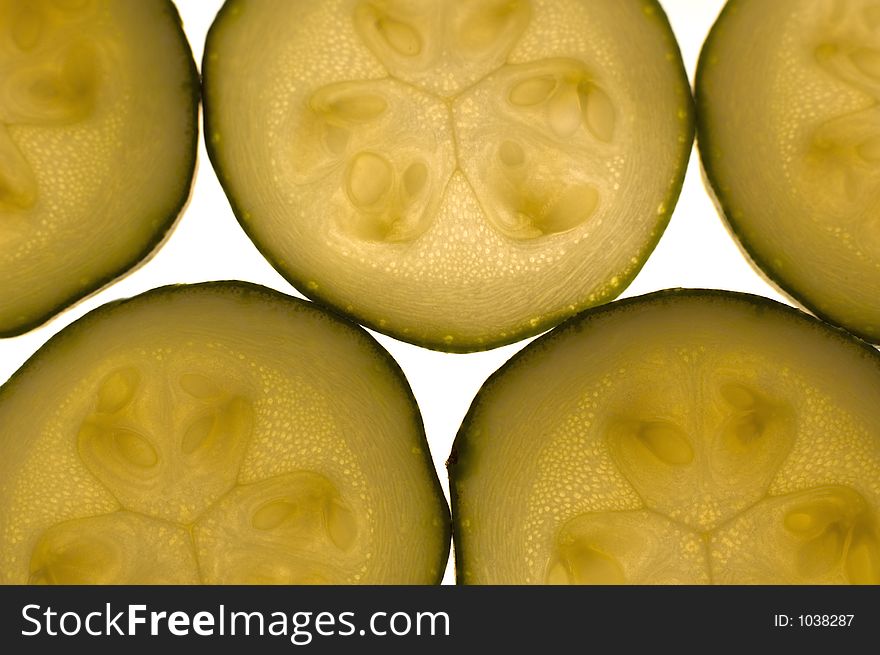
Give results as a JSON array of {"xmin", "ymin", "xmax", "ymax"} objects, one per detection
[{"xmin": 203, "ymin": 0, "xmax": 693, "ymax": 352}]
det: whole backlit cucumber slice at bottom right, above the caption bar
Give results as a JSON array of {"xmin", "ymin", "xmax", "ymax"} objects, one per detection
[{"xmin": 448, "ymin": 290, "xmax": 880, "ymax": 584}]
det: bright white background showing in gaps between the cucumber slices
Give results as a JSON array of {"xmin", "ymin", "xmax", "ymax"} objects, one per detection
[{"xmin": 0, "ymin": 0, "xmax": 784, "ymax": 583}]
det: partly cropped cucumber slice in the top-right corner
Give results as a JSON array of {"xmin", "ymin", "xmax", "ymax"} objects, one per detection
[{"xmin": 696, "ymin": 0, "xmax": 880, "ymax": 342}]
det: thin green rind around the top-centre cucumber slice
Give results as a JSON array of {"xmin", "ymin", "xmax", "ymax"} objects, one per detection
[{"xmin": 202, "ymin": 0, "xmax": 695, "ymax": 353}]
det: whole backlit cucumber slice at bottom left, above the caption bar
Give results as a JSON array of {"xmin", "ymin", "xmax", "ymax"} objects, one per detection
[{"xmin": 0, "ymin": 282, "xmax": 449, "ymax": 584}]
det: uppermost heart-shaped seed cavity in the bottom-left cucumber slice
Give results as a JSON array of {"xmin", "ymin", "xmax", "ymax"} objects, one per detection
[{"xmin": 76, "ymin": 366, "xmax": 255, "ymax": 523}]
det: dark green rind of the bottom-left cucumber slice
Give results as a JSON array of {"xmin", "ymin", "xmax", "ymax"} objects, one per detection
[{"xmin": 0, "ymin": 280, "xmax": 452, "ymax": 584}]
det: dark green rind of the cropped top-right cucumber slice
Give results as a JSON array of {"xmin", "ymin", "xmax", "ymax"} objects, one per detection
[{"xmin": 694, "ymin": 0, "xmax": 880, "ymax": 343}]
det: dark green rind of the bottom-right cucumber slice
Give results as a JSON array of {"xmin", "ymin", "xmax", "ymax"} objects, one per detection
[{"xmin": 446, "ymin": 288, "xmax": 880, "ymax": 584}]
